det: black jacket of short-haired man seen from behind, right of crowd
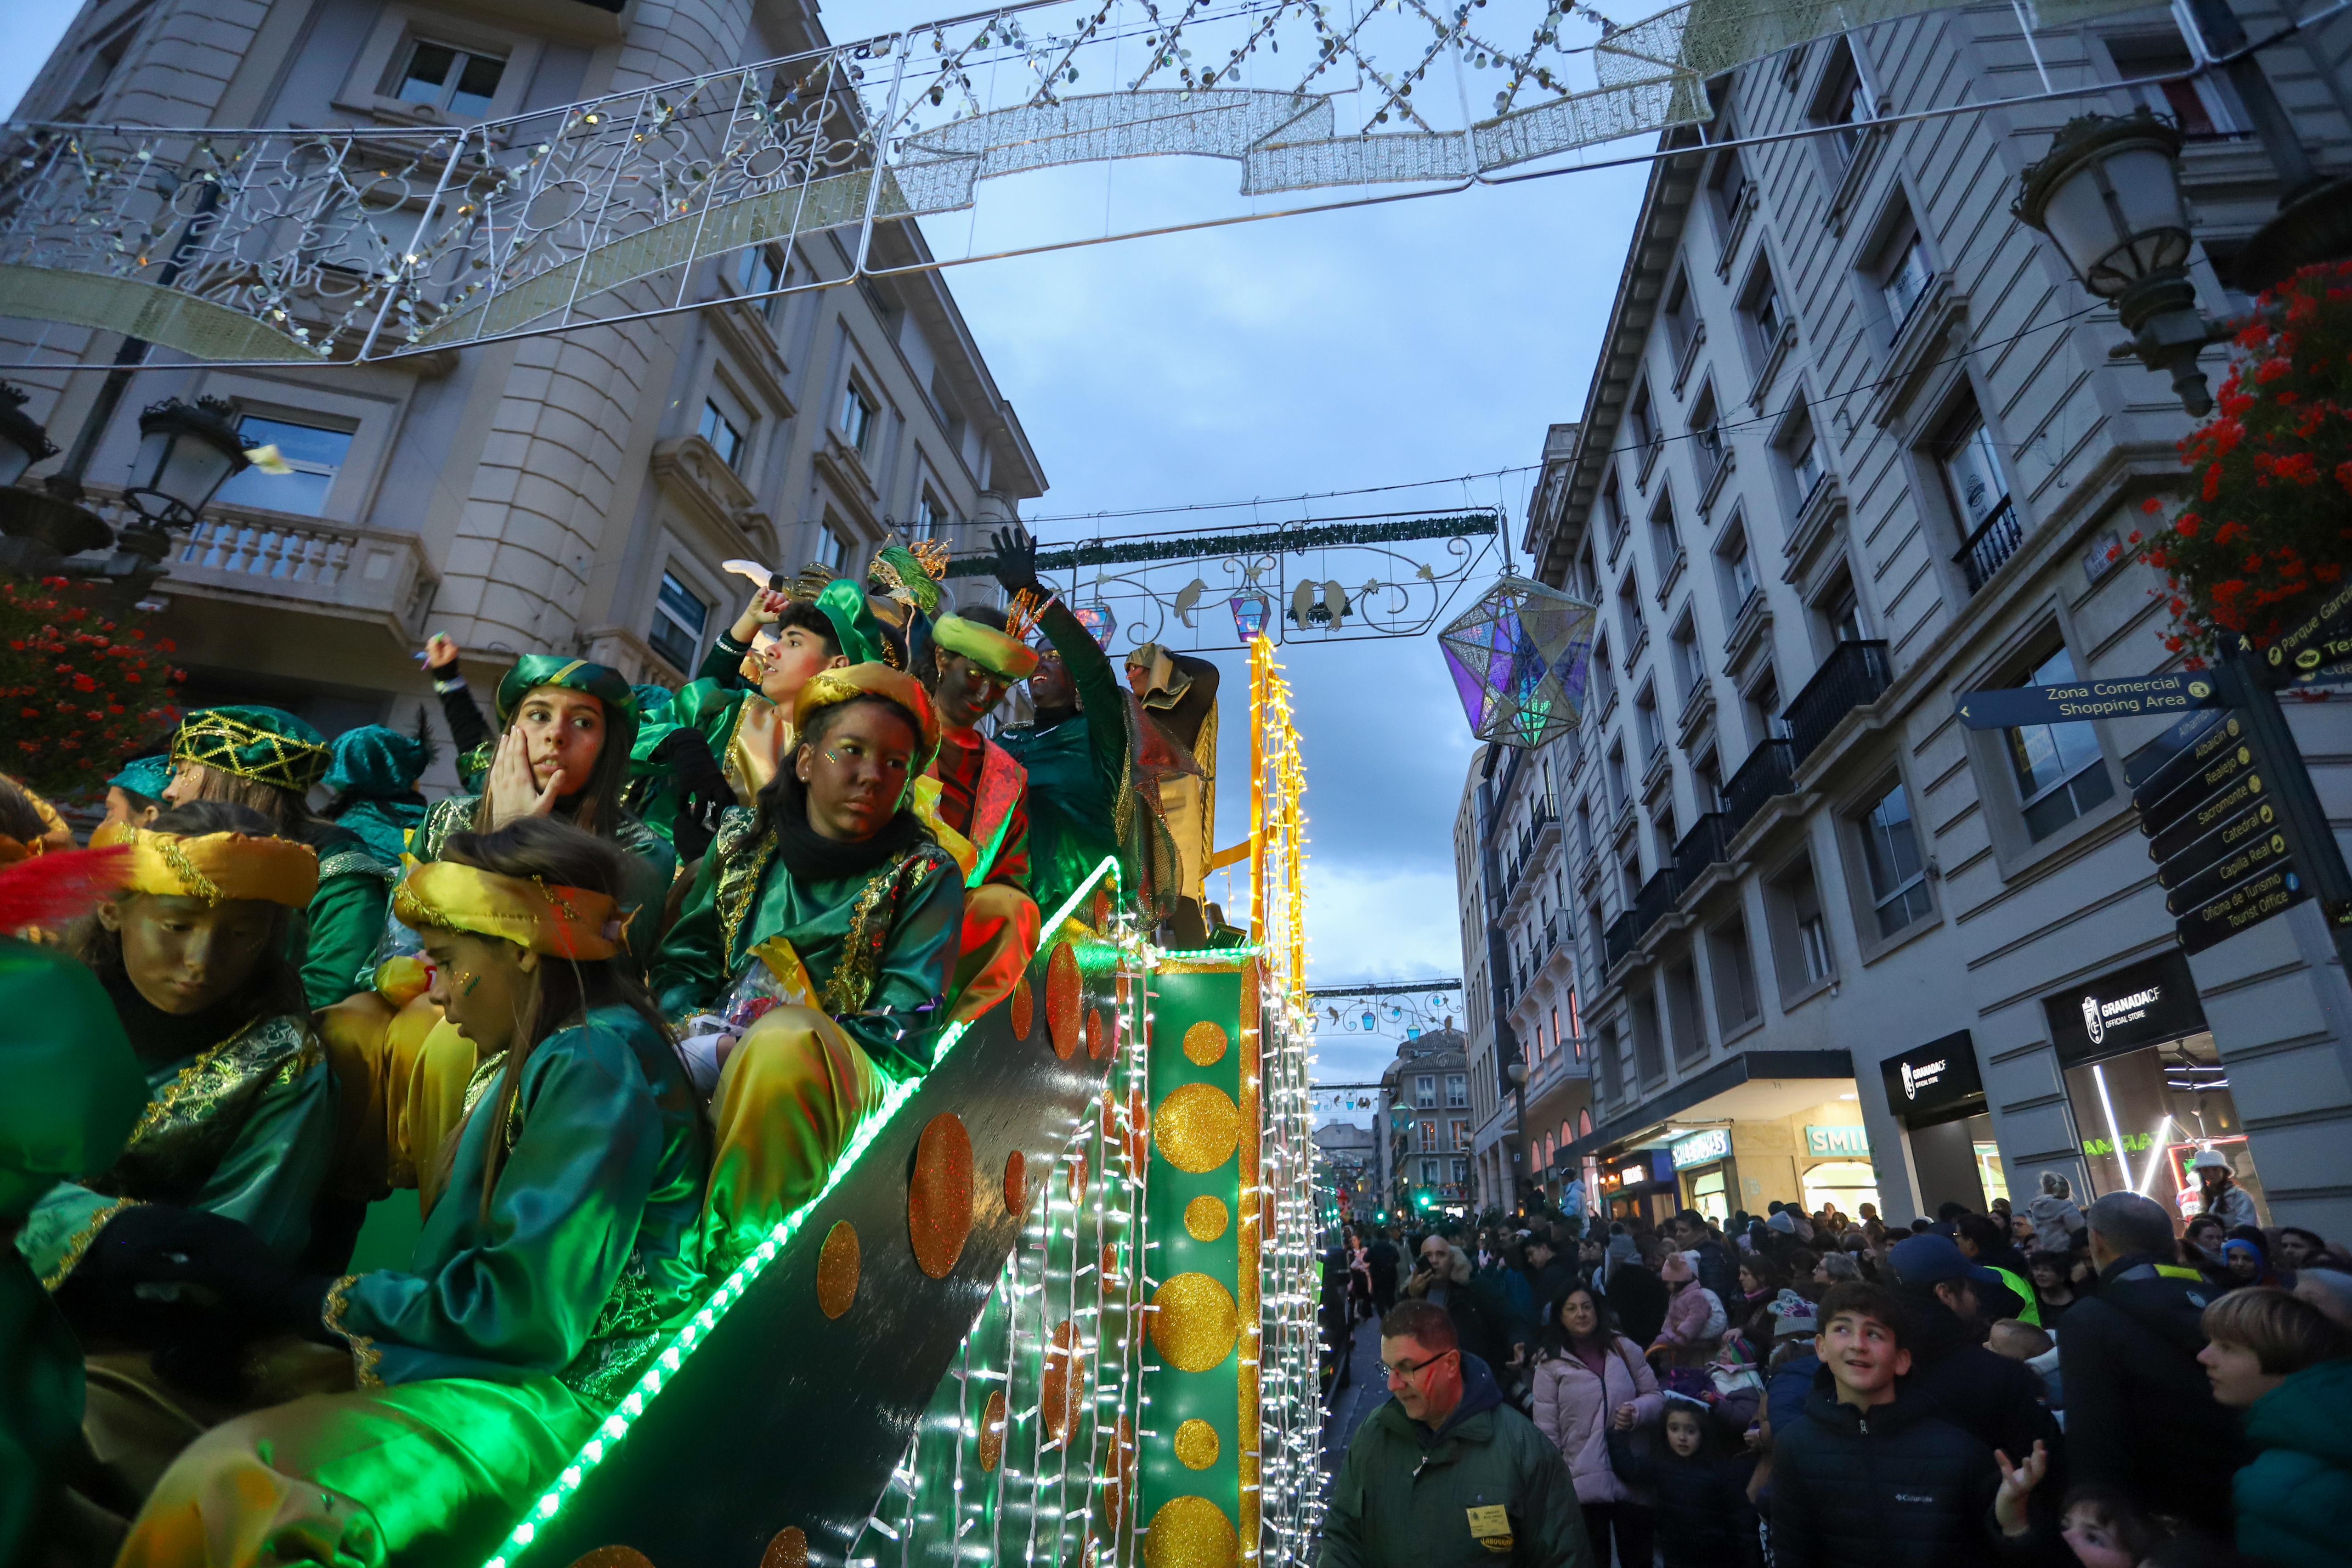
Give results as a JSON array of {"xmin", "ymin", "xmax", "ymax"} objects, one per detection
[{"xmin": 2060, "ymin": 1253, "xmax": 2246, "ymax": 1533}]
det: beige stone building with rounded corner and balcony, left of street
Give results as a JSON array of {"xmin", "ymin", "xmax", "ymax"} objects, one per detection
[{"xmin": 0, "ymin": 0, "xmax": 1044, "ymax": 761}]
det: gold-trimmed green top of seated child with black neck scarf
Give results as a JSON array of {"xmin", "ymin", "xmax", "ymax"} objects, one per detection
[{"xmin": 654, "ymin": 807, "xmax": 964, "ymax": 1077}]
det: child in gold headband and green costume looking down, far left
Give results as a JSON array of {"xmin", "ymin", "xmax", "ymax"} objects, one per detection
[{"xmin": 17, "ymin": 801, "xmax": 334, "ymax": 1345}]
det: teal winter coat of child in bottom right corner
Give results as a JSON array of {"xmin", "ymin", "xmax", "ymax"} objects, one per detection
[{"xmin": 2234, "ymin": 1361, "xmax": 2352, "ymax": 1568}]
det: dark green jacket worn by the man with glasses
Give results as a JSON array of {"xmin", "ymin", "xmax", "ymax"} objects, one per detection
[{"xmin": 1319, "ymin": 1356, "xmax": 1592, "ymax": 1568}]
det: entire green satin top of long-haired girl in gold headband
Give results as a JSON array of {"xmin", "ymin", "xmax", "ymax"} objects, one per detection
[{"xmin": 327, "ymin": 1006, "xmax": 710, "ymax": 1406}]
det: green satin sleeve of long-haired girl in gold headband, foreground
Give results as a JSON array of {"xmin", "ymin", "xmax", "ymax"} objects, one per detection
[{"xmin": 329, "ymin": 1010, "xmax": 663, "ymax": 1382}]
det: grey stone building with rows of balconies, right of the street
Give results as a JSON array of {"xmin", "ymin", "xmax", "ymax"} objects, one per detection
[{"xmin": 1489, "ymin": 5, "xmax": 2352, "ymax": 1234}]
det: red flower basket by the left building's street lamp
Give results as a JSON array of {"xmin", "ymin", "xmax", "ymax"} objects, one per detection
[{"xmin": 0, "ymin": 578, "xmax": 186, "ymax": 799}]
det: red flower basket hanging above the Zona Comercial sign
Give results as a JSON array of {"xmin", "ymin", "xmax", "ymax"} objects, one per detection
[{"xmin": 2131, "ymin": 263, "xmax": 2352, "ymax": 666}]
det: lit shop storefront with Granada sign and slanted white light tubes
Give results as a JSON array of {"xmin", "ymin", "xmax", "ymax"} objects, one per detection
[{"xmin": 2041, "ymin": 952, "xmax": 2270, "ymax": 1225}]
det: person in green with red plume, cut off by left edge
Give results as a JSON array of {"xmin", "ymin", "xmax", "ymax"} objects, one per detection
[{"xmin": 0, "ymin": 851, "xmax": 146, "ymax": 1563}]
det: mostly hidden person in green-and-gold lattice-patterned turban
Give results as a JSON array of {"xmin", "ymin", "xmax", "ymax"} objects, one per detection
[{"xmin": 162, "ymin": 705, "xmax": 400, "ymax": 1011}]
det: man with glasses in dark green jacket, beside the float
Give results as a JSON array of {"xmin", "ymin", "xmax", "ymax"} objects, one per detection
[{"xmin": 1319, "ymin": 1300, "xmax": 1592, "ymax": 1568}]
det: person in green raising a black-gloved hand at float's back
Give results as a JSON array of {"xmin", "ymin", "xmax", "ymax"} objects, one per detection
[{"xmin": 990, "ymin": 524, "xmax": 1176, "ymax": 926}]
